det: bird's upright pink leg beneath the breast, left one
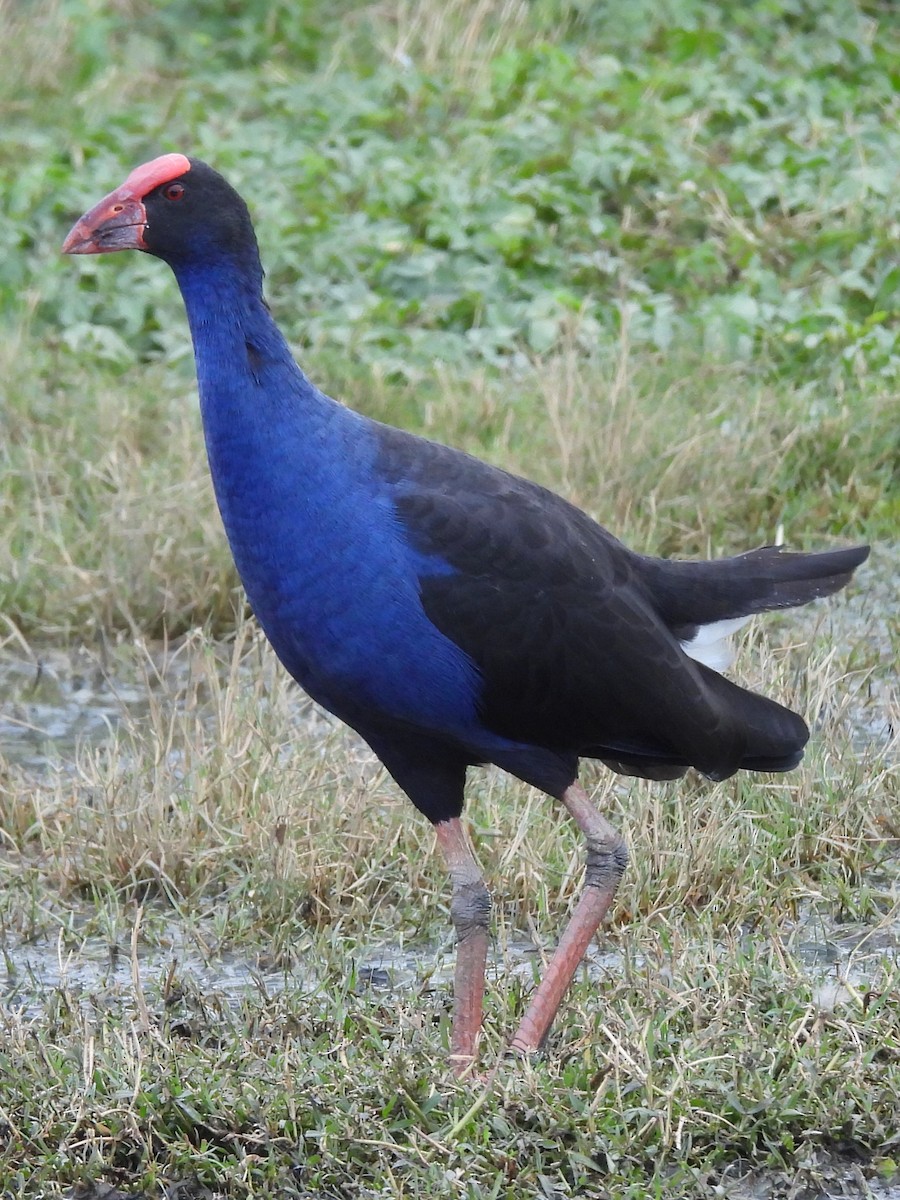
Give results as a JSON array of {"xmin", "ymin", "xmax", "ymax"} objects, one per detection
[{"xmin": 434, "ymin": 817, "xmax": 491, "ymax": 1075}]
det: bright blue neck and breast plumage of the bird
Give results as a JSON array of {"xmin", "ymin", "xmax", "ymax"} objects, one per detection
[{"xmin": 174, "ymin": 259, "xmax": 504, "ymax": 757}]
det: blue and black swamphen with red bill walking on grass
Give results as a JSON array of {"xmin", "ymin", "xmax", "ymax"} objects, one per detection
[{"xmin": 62, "ymin": 154, "xmax": 869, "ymax": 1075}]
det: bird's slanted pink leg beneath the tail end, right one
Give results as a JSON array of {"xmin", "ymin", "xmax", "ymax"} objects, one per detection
[{"xmin": 512, "ymin": 782, "xmax": 628, "ymax": 1052}]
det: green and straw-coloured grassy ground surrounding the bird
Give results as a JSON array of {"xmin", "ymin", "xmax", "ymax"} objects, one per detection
[{"xmin": 0, "ymin": 0, "xmax": 900, "ymax": 1200}]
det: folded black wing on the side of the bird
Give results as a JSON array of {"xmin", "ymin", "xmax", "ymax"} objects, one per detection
[{"xmin": 377, "ymin": 427, "xmax": 777, "ymax": 775}]
